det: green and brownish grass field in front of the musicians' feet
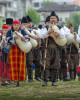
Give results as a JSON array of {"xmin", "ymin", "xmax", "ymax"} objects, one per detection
[{"xmin": 0, "ymin": 80, "xmax": 80, "ymax": 100}]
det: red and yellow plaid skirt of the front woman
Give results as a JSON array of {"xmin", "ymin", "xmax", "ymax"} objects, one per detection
[{"xmin": 8, "ymin": 45, "xmax": 26, "ymax": 81}]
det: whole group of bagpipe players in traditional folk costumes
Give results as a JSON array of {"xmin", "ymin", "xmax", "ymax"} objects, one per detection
[{"xmin": 0, "ymin": 11, "xmax": 80, "ymax": 87}]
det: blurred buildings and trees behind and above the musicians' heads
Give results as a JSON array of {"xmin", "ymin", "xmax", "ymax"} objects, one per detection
[{"xmin": 0, "ymin": 0, "xmax": 80, "ymax": 31}]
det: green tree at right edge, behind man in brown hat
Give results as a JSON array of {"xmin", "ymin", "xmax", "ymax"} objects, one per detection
[{"xmin": 66, "ymin": 13, "xmax": 80, "ymax": 32}]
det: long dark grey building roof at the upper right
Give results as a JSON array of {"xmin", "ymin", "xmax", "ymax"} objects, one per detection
[{"xmin": 37, "ymin": 3, "xmax": 80, "ymax": 12}]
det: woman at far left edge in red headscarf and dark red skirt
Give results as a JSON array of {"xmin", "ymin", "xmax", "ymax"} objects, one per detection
[{"xmin": 0, "ymin": 25, "xmax": 10, "ymax": 86}]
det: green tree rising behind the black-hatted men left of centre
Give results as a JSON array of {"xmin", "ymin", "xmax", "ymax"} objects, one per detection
[{"xmin": 26, "ymin": 8, "xmax": 40, "ymax": 25}]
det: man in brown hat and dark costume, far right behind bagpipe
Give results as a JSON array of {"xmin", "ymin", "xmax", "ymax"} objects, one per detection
[{"xmin": 67, "ymin": 23, "xmax": 78, "ymax": 80}]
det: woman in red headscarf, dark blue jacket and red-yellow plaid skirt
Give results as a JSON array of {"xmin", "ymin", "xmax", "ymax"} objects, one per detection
[{"xmin": 6, "ymin": 20, "xmax": 28, "ymax": 87}]
